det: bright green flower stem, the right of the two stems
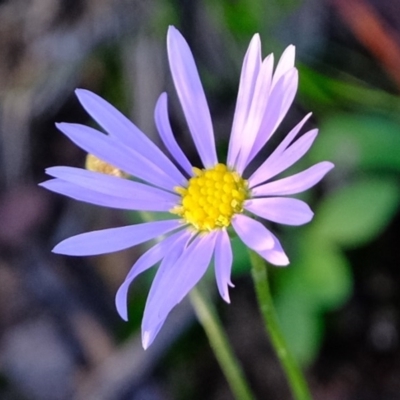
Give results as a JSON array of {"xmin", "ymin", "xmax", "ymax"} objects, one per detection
[{"xmin": 249, "ymin": 250, "xmax": 312, "ymax": 400}]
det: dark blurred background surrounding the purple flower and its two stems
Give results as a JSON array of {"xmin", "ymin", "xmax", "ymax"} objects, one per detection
[{"xmin": 0, "ymin": 0, "xmax": 400, "ymax": 400}]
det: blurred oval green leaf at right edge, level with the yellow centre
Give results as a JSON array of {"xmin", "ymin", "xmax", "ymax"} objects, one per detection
[{"xmin": 313, "ymin": 178, "xmax": 400, "ymax": 247}]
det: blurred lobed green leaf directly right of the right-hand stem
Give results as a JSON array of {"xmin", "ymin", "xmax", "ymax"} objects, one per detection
[{"xmin": 275, "ymin": 228, "xmax": 353, "ymax": 364}]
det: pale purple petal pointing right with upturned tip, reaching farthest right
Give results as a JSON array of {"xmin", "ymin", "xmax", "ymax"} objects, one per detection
[{"xmin": 251, "ymin": 161, "xmax": 334, "ymax": 197}]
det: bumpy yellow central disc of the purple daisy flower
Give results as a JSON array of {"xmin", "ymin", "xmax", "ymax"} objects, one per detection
[{"xmin": 171, "ymin": 164, "xmax": 248, "ymax": 231}]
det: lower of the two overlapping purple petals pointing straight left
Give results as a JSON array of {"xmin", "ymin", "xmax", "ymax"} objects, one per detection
[{"xmin": 39, "ymin": 179, "xmax": 176, "ymax": 211}]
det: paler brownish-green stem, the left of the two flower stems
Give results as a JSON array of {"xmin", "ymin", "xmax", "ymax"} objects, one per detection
[{"xmin": 190, "ymin": 285, "xmax": 255, "ymax": 400}]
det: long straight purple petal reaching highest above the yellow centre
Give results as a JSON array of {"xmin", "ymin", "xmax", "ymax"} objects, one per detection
[{"xmin": 167, "ymin": 26, "xmax": 217, "ymax": 168}]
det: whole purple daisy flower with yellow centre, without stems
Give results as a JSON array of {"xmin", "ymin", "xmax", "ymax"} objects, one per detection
[{"xmin": 41, "ymin": 27, "xmax": 333, "ymax": 348}]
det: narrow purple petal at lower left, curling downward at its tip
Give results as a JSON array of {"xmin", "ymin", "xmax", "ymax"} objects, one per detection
[{"xmin": 115, "ymin": 230, "xmax": 187, "ymax": 321}]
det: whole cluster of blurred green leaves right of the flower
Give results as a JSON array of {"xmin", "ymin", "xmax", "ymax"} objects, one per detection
[{"xmin": 248, "ymin": 110, "xmax": 400, "ymax": 364}]
